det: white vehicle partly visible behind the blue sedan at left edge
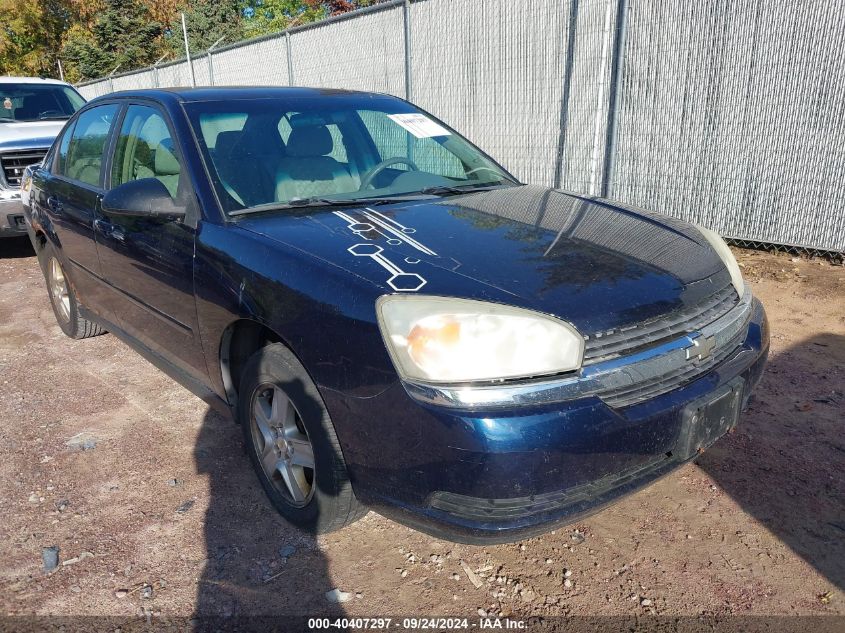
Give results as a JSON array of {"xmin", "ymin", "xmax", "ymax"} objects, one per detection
[{"xmin": 0, "ymin": 77, "xmax": 85, "ymax": 238}]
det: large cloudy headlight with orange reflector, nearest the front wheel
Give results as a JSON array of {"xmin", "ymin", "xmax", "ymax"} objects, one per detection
[{"xmin": 376, "ymin": 295, "xmax": 584, "ymax": 382}]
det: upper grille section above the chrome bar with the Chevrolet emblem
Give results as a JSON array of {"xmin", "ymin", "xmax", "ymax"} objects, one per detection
[{"xmin": 584, "ymin": 285, "xmax": 739, "ymax": 365}]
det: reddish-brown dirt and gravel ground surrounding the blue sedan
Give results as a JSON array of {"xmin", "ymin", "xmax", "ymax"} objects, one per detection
[{"xmin": 0, "ymin": 242, "xmax": 845, "ymax": 617}]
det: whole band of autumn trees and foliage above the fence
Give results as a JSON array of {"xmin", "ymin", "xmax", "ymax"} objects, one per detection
[{"xmin": 0, "ymin": 0, "xmax": 382, "ymax": 82}]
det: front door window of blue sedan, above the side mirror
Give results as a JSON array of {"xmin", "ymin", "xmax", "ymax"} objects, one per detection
[{"xmin": 111, "ymin": 105, "xmax": 182, "ymax": 199}]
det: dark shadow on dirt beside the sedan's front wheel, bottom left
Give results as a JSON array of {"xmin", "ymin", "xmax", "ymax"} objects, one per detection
[{"xmin": 194, "ymin": 390, "xmax": 345, "ymax": 630}]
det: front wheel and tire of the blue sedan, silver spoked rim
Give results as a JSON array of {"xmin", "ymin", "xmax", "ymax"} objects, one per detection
[{"xmin": 238, "ymin": 343, "xmax": 367, "ymax": 534}]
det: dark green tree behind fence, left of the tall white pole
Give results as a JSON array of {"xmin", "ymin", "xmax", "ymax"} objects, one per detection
[{"xmin": 62, "ymin": 0, "xmax": 162, "ymax": 79}]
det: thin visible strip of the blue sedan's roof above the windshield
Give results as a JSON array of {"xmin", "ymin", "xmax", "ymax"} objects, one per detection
[{"xmin": 95, "ymin": 86, "xmax": 389, "ymax": 102}]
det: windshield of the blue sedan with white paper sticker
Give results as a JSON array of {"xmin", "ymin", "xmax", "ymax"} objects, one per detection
[{"xmin": 185, "ymin": 94, "xmax": 517, "ymax": 215}]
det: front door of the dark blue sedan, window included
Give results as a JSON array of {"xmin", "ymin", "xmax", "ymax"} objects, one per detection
[{"xmin": 96, "ymin": 104, "xmax": 207, "ymax": 378}]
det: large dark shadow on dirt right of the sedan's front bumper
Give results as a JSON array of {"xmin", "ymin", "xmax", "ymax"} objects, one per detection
[{"xmin": 697, "ymin": 334, "xmax": 845, "ymax": 589}]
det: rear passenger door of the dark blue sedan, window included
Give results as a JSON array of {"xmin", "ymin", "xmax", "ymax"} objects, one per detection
[{"xmin": 41, "ymin": 103, "xmax": 120, "ymax": 320}]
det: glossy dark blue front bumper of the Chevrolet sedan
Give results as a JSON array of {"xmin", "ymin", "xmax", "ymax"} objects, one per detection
[{"xmin": 325, "ymin": 299, "xmax": 769, "ymax": 543}]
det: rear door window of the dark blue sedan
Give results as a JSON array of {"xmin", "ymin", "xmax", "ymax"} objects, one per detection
[{"xmin": 57, "ymin": 104, "xmax": 118, "ymax": 187}]
